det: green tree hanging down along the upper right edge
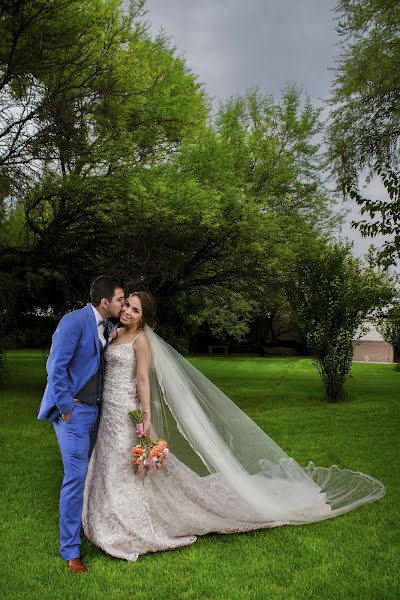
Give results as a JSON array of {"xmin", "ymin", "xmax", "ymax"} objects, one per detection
[{"xmin": 328, "ymin": 0, "xmax": 400, "ymax": 266}]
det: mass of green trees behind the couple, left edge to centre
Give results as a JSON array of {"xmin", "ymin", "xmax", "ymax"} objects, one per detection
[{"xmin": 0, "ymin": 0, "xmax": 334, "ymax": 349}]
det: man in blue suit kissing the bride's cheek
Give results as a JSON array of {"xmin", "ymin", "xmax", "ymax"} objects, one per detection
[{"xmin": 38, "ymin": 276, "xmax": 124, "ymax": 573}]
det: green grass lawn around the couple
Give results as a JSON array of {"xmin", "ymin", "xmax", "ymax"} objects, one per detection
[{"xmin": 0, "ymin": 351, "xmax": 400, "ymax": 600}]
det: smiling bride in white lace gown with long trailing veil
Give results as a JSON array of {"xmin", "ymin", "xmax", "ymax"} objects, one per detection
[{"xmin": 82, "ymin": 292, "xmax": 385, "ymax": 561}]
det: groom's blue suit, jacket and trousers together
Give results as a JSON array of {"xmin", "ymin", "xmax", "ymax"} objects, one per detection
[{"xmin": 38, "ymin": 304, "xmax": 107, "ymax": 560}]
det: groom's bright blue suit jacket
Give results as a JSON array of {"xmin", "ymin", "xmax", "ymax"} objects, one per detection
[{"xmin": 38, "ymin": 304, "xmax": 108, "ymax": 421}]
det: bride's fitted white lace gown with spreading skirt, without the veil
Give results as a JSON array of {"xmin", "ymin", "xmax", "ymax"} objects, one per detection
[{"xmin": 82, "ymin": 343, "xmax": 285, "ymax": 561}]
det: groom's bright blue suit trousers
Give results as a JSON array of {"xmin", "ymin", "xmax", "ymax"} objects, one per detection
[{"xmin": 54, "ymin": 404, "xmax": 100, "ymax": 560}]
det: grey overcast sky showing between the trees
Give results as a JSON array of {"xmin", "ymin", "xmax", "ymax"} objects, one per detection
[{"xmin": 146, "ymin": 0, "xmax": 392, "ymax": 262}]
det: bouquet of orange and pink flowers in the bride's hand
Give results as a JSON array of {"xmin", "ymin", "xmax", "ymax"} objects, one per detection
[{"xmin": 129, "ymin": 410, "xmax": 169, "ymax": 477}]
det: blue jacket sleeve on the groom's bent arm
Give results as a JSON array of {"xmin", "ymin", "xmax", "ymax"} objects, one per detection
[{"xmin": 46, "ymin": 314, "xmax": 81, "ymax": 414}]
